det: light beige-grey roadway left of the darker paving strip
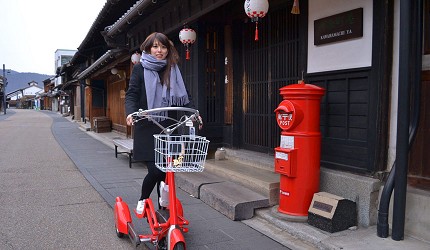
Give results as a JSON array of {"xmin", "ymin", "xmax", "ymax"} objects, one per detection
[{"xmin": 0, "ymin": 109, "xmax": 130, "ymax": 249}]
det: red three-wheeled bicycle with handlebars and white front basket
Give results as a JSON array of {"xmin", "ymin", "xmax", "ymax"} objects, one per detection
[{"xmin": 114, "ymin": 107, "xmax": 209, "ymax": 250}]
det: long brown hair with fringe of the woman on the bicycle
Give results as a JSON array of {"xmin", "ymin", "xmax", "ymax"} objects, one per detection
[{"xmin": 140, "ymin": 32, "xmax": 179, "ymax": 87}]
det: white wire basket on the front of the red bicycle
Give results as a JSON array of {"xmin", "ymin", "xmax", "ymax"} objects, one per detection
[{"xmin": 154, "ymin": 134, "xmax": 209, "ymax": 172}]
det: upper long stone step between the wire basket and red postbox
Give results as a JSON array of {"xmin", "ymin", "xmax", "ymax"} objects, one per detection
[{"xmin": 205, "ymin": 156, "xmax": 279, "ymax": 206}]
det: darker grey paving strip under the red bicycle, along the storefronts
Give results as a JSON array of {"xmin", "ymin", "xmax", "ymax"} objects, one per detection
[{"xmin": 52, "ymin": 114, "xmax": 288, "ymax": 250}]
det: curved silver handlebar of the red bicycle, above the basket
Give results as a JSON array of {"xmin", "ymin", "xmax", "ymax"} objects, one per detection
[{"xmin": 130, "ymin": 107, "xmax": 203, "ymax": 135}]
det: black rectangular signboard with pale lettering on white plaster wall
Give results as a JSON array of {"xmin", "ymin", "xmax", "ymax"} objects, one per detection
[{"xmin": 314, "ymin": 8, "xmax": 363, "ymax": 45}]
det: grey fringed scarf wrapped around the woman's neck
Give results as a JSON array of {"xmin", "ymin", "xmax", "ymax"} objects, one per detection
[{"xmin": 140, "ymin": 53, "xmax": 190, "ymax": 112}]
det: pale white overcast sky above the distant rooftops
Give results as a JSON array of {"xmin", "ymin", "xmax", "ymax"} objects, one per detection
[{"xmin": 0, "ymin": 0, "xmax": 106, "ymax": 75}]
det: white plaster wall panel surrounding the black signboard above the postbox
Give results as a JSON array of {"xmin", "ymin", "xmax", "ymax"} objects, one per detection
[{"xmin": 308, "ymin": 0, "xmax": 373, "ymax": 73}]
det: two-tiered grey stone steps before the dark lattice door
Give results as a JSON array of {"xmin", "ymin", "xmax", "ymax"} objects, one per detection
[{"xmin": 176, "ymin": 150, "xmax": 279, "ymax": 220}]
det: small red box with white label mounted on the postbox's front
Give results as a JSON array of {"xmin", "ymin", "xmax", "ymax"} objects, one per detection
[{"xmin": 275, "ymin": 147, "xmax": 297, "ymax": 177}]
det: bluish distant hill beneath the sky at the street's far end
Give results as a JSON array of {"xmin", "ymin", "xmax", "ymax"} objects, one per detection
[{"xmin": 0, "ymin": 70, "xmax": 53, "ymax": 93}]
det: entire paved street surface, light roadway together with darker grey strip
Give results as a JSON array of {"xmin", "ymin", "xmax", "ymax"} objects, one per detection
[{"xmin": 0, "ymin": 109, "xmax": 286, "ymax": 249}]
